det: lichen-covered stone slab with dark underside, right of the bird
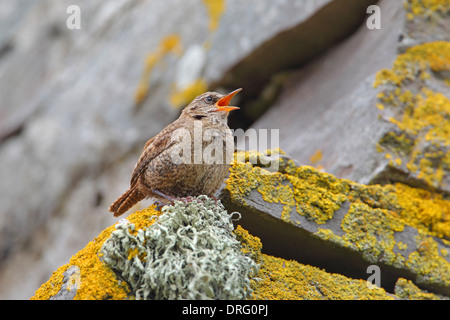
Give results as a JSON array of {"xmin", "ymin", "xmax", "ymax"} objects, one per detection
[{"xmin": 222, "ymin": 151, "xmax": 450, "ymax": 295}]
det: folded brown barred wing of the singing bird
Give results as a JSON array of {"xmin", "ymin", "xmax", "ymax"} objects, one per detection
[{"xmin": 130, "ymin": 125, "xmax": 176, "ymax": 187}]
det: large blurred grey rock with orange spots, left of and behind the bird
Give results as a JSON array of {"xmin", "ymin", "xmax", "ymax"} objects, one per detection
[{"xmin": 0, "ymin": 0, "xmax": 373, "ymax": 299}]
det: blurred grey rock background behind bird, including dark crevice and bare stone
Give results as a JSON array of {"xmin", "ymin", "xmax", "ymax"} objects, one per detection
[{"xmin": 0, "ymin": 0, "xmax": 448, "ymax": 299}]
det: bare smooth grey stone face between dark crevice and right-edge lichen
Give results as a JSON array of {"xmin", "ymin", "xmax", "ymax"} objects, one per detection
[{"xmin": 252, "ymin": 1, "xmax": 404, "ymax": 188}]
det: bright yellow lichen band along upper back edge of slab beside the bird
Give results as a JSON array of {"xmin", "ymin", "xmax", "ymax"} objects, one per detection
[{"xmin": 226, "ymin": 152, "xmax": 450, "ymax": 237}]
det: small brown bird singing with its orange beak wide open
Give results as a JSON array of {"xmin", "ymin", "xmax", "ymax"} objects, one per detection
[{"xmin": 109, "ymin": 89, "xmax": 242, "ymax": 217}]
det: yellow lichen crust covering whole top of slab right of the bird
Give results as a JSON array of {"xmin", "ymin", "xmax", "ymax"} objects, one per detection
[{"xmin": 226, "ymin": 152, "xmax": 450, "ymax": 286}]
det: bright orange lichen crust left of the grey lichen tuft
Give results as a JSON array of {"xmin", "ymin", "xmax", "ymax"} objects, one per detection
[{"xmin": 31, "ymin": 206, "xmax": 161, "ymax": 300}]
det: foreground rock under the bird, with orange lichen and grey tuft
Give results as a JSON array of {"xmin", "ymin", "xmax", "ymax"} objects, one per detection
[{"xmin": 32, "ymin": 188, "xmax": 445, "ymax": 300}]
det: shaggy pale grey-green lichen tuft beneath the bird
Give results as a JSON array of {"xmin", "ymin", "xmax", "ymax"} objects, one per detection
[{"xmin": 101, "ymin": 196, "xmax": 258, "ymax": 299}]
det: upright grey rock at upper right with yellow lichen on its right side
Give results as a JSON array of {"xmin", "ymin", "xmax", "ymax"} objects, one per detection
[{"xmin": 253, "ymin": 0, "xmax": 450, "ymax": 193}]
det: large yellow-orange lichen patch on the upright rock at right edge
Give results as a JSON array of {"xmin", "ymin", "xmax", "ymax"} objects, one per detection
[{"xmin": 374, "ymin": 41, "xmax": 450, "ymax": 189}]
